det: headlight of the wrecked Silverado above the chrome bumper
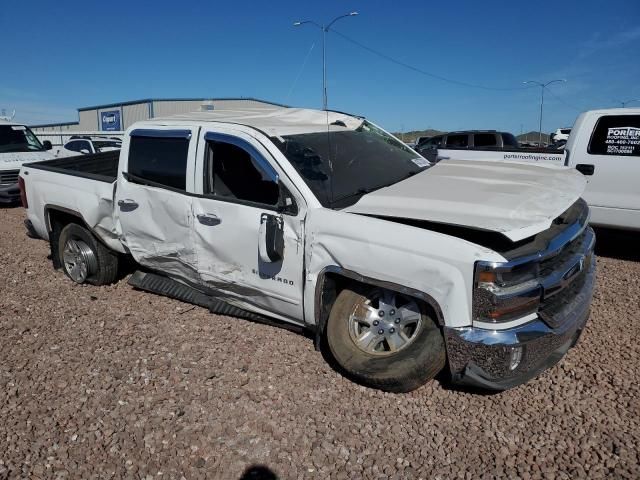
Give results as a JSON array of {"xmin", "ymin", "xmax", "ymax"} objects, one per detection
[{"xmin": 473, "ymin": 262, "xmax": 542, "ymax": 323}]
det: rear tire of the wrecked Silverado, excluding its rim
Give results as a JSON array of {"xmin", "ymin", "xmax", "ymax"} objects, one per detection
[{"xmin": 58, "ymin": 223, "xmax": 118, "ymax": 285}]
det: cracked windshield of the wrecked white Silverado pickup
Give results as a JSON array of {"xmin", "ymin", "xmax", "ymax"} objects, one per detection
[{"xmin": 271, "ymin": 120, "xmax": 430, "ymax": 208}]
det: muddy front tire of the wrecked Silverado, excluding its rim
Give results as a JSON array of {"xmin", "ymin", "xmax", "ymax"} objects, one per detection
[{"xmin": 327, "ymin": 287, "xmax": 446, "ymax": 393}]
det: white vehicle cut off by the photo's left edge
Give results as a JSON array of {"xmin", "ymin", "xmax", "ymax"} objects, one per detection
[{"xmin": 0, "ymin": 120, "xmax": 53, "ymax": 205}]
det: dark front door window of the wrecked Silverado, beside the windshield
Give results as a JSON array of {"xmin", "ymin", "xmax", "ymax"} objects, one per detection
[{"xmin": 205, "ymin": 140, "xmax": 279, "ymax": 206}]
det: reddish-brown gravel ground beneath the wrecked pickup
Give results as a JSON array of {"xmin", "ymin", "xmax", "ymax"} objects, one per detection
[{"xmin": 0, "ymin": 208, "xmax": 640, "ymax": 479}]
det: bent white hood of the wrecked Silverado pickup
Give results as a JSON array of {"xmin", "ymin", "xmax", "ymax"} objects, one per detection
[{"xmin": 345, "ymin": 160, "xmax": 586, "ymax": 242}]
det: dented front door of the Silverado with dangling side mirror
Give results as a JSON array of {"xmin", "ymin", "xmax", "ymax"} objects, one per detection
[{"xmin": 193, "ymin": 128, "xmax": 306, "ymax": 323}]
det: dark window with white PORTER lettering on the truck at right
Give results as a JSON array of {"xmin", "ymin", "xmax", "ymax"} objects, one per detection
[{"xmin": 587, "ymin": 115, "xmax": 640, "ymax": 157}]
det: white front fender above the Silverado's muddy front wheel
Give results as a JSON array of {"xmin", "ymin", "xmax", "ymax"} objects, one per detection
[{"xmin": 305, "ymin": 209, "xmax": 504, "ymax": 327}]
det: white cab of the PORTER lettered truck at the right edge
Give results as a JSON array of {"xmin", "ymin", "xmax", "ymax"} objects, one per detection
[{"xmin": 565, "ymin": 108, "xmax": 640, "ymax": 230}]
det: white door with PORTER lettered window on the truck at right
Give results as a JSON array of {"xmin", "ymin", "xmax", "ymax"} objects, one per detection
[{"xmin": 569, "ymin": 114, "xmax": 640, "ymax": 210}]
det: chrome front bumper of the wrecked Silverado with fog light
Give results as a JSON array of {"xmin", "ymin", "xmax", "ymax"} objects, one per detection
[{"xmin": 444, "ymin": 255, "xmax": 595, "ymax": 390}]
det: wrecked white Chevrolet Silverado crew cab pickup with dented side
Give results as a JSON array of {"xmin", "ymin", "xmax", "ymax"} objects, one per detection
[{"xmin": 21, "ymin": 109, "xmax": 595, "ymax": 392}]
